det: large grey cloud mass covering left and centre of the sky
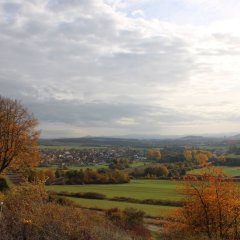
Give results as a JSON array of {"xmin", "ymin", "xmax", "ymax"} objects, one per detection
[{"xmin": 0, "ymin": 0, "xmax": 238, "ymax": 135}]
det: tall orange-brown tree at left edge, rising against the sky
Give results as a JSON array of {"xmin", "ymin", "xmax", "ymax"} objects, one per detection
[{"xmin": 0, "ymin": 96, "xmax": 39, "ymax": 173}]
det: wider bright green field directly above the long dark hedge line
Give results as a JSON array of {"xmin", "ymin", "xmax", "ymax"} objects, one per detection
[{"xmin": 46, "ymin": 180, "xmax": 182, "ymax": 201}]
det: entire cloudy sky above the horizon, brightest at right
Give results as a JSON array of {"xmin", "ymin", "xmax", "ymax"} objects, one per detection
[{"xmin": 0, "ymin": 0, "xmax": 240, "ymax": 138}]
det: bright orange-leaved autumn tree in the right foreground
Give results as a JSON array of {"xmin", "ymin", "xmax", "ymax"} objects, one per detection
[{"xmin": 166, "ymin": 168, "xmax": 240, "ymax": 240}]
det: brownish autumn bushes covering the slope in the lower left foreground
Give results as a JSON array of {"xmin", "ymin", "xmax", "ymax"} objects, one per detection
[{"xmin": 0, "ymin": 184, "xmax": 134, "ymax": 240}]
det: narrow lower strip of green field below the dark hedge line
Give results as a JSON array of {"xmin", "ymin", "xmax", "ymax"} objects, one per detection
[{"xmin": 67, "ymin": 197, "xmax": 177, "ymax": 217}]
